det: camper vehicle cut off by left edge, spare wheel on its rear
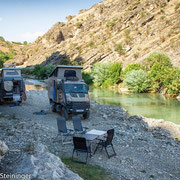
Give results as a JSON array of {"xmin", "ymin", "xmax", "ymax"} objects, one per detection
[{"xmin": 0, "ymin": 68, "xmax": 25, "ymax": 103}]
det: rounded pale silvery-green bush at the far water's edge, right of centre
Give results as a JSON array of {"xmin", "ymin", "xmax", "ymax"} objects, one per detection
[{"xmin": 124, "ymin": 69, "xmax": 149, "ymax": 93}]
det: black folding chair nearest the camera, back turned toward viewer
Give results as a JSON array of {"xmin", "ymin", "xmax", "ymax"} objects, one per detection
[{"xmin": 72, "ymin": 137, "xmax": 92, "ymax": 163}]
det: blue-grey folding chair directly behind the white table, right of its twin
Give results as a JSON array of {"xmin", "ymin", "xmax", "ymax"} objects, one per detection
[{"xmin": 72, "ymin": 116, "xmax": 89, "ymax": 134}]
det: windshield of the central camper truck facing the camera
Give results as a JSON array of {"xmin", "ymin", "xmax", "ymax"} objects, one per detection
[{"xmin": 64, "ymin": 84, "xmax": 88, "ymax": 94}]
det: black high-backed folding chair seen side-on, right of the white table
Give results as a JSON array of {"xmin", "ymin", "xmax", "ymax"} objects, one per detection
[{"xmin": 94, "ymin": 129, "xmax": 116, "ymax": 158}]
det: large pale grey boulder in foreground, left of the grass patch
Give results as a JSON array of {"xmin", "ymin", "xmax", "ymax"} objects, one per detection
[{"xmin": 13, "ymin": 144, "xmax": 82, "ymax": 180}]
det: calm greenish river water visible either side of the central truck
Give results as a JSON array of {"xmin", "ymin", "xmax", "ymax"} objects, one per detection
[{"xmin": 25, "ymin": 80, "xmax": 180, "ymax": 124}]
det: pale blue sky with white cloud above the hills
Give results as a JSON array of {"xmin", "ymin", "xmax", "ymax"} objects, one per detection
[{"xmin": 0, "ymin": 0, "xmax": 102, "ymax": 42}]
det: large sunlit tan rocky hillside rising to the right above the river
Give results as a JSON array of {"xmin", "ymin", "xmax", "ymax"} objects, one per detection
[{"xmin": 6, "ymin": 0, "xmax": 180, "ymax": 70}]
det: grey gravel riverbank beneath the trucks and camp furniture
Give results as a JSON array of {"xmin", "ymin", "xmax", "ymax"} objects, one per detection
[{"xmin": 0, "ymin": 91, "xmax": 180, "ymax": 180}]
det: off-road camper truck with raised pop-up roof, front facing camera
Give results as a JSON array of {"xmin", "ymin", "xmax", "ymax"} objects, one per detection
[{"xmin": 48, "ymin": 66, "xmax": 90, "ymax": 119}]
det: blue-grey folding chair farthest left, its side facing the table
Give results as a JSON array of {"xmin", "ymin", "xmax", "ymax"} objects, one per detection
[{"xmin": 57, "ymin": 117, "xmax": 74, "ymax": 145}]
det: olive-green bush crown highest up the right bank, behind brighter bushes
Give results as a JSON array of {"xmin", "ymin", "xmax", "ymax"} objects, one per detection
[{"xmin": 143, "ymin": 52, "xmax": 171, "ymax": 71}]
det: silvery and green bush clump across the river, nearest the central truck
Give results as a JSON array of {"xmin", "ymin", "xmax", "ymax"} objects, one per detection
[{"xmin": 92, "ymin": 63, "xmax": 122, "ymax": 87}]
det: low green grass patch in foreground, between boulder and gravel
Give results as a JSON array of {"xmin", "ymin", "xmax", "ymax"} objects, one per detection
[{"xmin": 61, "ymin": 157, "xmax": 112, "ymax": 180}]
